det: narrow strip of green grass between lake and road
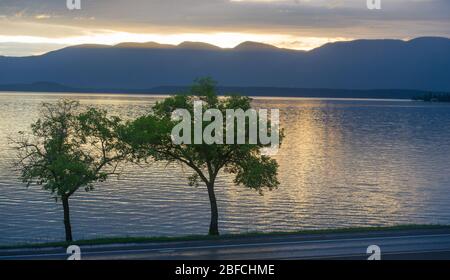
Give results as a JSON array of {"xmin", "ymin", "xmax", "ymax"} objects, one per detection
[{"xmin": 0, "ymin": 225, "xmax": 450, "ymax": 249}]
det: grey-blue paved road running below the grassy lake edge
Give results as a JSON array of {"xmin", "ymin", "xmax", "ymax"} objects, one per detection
[{"xmin": 0, "ymin": 229, "xmax": 450, "ymax": 260}]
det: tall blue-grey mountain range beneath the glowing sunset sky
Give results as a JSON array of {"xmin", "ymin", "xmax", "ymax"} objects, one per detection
[{"xmin": 0, "ymin": 37, "xmax": 450, "ymax": 92}]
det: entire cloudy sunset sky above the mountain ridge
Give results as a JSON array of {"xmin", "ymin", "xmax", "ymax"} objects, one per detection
[{"xmin": 0, "ymin": 0, "xmax": 450, "ymax": 56}]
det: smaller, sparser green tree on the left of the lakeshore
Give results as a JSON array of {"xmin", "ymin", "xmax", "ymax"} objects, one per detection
[{"xmin": 13, "ymin": 100, "xmax": 126, "ymax": 242}]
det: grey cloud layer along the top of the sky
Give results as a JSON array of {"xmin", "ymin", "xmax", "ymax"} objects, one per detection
[{"xmin": 0, "ymin": 0, "xmax": 450, "ymax": 29}]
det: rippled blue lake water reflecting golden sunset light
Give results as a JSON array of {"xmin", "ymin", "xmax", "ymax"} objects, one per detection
[{"xmin": 0, "ymin": 93, "xmax": 450, "ymax": 244}]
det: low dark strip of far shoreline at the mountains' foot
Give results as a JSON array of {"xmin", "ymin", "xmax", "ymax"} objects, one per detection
[{"xmin": 0, "ymin": 82, "xmax": 439, "ymax": 99}]
